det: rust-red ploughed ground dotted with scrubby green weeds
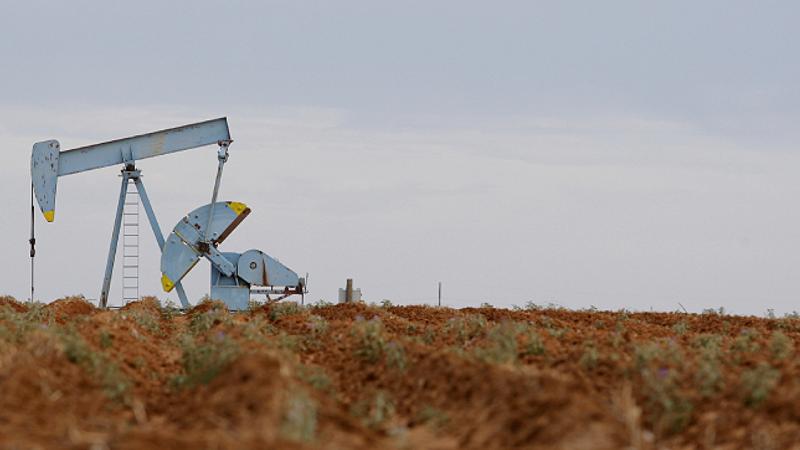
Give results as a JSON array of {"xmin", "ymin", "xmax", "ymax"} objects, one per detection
[{"xmin": 0, "ymin": 297, "xmax": 800, "ymax": 449}]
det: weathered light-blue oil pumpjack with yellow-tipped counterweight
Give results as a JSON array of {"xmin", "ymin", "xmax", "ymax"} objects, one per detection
[{"xmin": 30, "ymin": 117, "xmax": 306, "ymax": 310}]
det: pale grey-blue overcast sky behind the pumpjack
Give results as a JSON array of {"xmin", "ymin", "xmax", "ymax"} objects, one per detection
[{"xmin": 0, "ymin": 0, "xmax": 800, "ymax": 315}]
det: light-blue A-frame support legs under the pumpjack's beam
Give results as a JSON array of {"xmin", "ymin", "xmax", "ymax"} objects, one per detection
[{"xmin": 100, "ymin": 165, "xmax": 191, "ymax": 308}]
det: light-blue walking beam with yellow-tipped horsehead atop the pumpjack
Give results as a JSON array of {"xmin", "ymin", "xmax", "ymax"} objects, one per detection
[{"xmin": 31, "ymin": 117, "xmax": 231, "ymax": 222}]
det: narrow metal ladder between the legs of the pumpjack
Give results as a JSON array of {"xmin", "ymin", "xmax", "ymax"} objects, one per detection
[{"xmin": 122, "ymin": 180, "xmax": 139, "ymax": 305}]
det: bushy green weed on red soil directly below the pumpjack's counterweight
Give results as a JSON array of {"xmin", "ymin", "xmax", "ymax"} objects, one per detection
[{"xmin": 172, "ymin": 334, "xmax": 240, "ymax": 388}]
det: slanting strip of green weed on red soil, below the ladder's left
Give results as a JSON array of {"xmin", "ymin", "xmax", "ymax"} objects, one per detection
[{"xmin": 59, "ymin": 330, "xmax": 130, "ymax": 400}]
